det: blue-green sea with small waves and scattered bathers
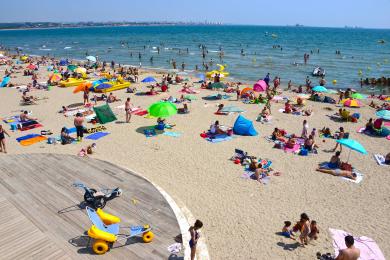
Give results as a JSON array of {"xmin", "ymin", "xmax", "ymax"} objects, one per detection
[{"xmin": 0, "ymin": 26, "xmax": 390, "ymax": 92}]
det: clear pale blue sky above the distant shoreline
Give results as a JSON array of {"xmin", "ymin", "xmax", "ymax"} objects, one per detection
[{"xmin": 0, "ymin": 0, "xmax": 390, "ymax": 29}]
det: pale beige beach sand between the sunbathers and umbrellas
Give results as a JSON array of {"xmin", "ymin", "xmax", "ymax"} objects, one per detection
[{"xmin": 0, "ymin": 64, "xmax": 390, "ymax": 259}]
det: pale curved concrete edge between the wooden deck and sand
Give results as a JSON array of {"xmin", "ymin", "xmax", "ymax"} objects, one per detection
[{"xmin": 91, "ymin": 157, "xmax": 210, "ymax": 260}]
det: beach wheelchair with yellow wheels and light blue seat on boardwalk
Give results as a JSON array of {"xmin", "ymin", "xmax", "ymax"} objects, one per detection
[{"xmin": 86, "ymin": 207, "xmax": 154, "ymax": 255}]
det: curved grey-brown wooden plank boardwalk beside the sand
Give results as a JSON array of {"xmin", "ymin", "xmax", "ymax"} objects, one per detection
[{"xmin": 0, "ymin": 154, "xmax": 182, "ymax": 259}]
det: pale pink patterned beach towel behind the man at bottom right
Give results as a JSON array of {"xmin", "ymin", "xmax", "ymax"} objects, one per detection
[{"xmin": 329, "ymin": 228, "xmax": 385, "ymax": 260}]
